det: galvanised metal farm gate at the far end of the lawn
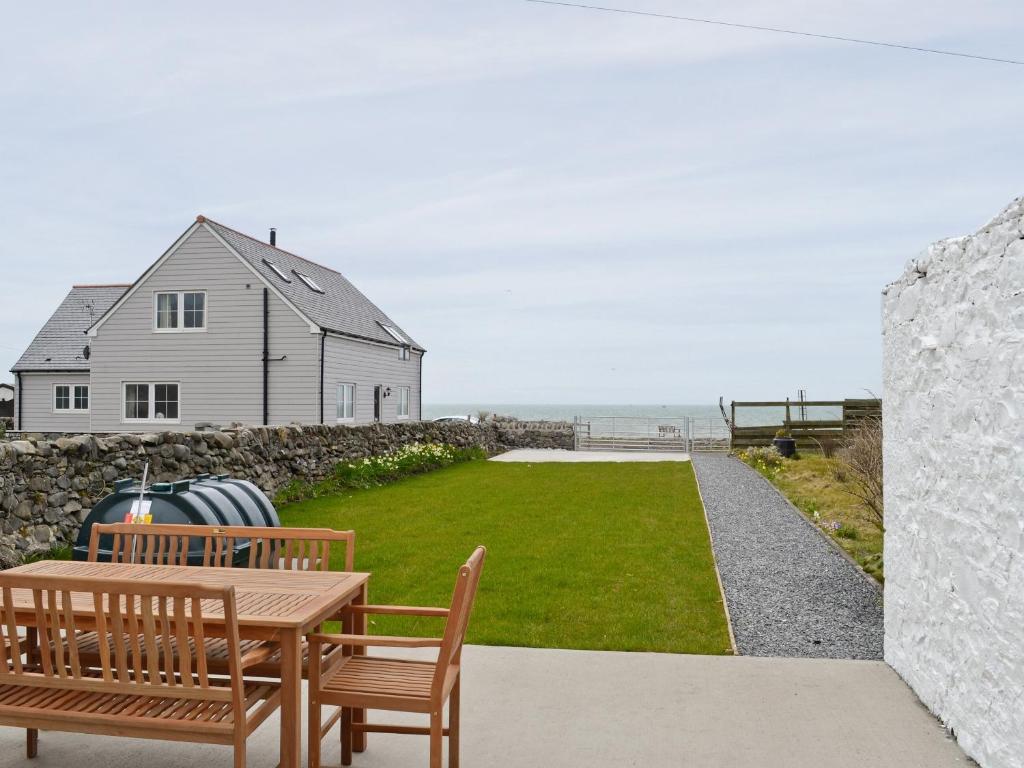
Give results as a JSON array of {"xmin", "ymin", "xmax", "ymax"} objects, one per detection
[{"xmin": 572, "ymin": 416, "xmax": 731, "ymax": 453}]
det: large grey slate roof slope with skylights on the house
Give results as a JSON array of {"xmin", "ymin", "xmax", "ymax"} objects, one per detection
[{"xmin": 201, "ymin": 217, "xmax": 423, "ymax": 350}]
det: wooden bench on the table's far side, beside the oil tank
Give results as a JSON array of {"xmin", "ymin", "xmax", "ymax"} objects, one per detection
[{"xmin": 80, "ymin": 522, "xmax": 355, "ymax": 679}]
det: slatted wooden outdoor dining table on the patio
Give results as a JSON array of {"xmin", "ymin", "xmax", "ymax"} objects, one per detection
[{"xmin": 10, "ymin": 560, "xmax": 370, "ymax": 768}]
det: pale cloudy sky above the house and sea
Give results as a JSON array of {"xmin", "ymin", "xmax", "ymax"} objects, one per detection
[{"xmin": 0, "ymin": 0, "xmax": 1024, "ymax": 404}]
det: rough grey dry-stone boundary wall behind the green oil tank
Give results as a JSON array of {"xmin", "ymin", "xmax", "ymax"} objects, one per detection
[{"xmin": 0, "ymin": 422, "xmax": 572, "ymax": 565}]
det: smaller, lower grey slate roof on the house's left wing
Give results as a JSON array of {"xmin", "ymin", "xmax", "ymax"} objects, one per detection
[{"xmin": 11, "ymin": 285, "xmax": 128, "ymax": 371}]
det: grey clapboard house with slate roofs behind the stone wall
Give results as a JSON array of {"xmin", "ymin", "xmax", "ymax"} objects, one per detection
[{"xmin": 11, "ymin": 216, "xmax": 425, "ymax": 432}]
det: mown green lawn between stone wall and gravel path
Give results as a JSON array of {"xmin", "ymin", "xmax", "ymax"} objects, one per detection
[{"xmin": 281, "ymin": 461, "xmax": 729, "ymax": 653}]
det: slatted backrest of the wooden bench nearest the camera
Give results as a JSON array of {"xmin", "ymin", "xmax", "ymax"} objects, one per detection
[{"xmin": 0, "ymin": 573, "xmax": 245, "ymax": 704}]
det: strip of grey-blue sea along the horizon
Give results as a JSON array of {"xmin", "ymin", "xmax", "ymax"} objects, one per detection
[{"xmin": 423, "ymin": 402, "xmax": 842, "ymax": 427}]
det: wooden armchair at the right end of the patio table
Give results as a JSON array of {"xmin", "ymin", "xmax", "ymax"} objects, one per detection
[{"xmin": 308, "ymin": 547, "xmax": 486, "ymax": 768}]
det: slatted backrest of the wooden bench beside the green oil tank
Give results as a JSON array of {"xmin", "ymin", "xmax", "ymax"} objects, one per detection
[{"xmin": 88, "ymin": 522, "xmax": 355, "ymax": 570}]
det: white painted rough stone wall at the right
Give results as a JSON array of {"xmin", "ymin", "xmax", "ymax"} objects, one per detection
[{"xmin": 883, "ymin": 199, "xmax": 1024, "ymax": 768}]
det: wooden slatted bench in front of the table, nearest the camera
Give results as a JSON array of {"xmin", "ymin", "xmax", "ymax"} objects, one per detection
[{"xmin": 0, "ymin": 573, "xmax": 281, "ymax": 768}]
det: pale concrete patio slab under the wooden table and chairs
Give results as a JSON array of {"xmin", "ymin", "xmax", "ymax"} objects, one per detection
[{"xmin": 0, "ymin": 646, "xmax": 973, "ymax": 768}]
